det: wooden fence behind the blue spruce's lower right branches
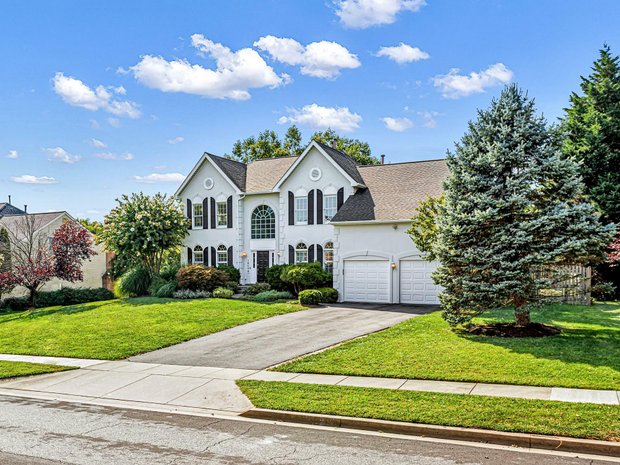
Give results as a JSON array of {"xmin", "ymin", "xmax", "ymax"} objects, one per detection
[{"xmin": 540, "ymin": 265, "xmax": 592, "ymax": 305}]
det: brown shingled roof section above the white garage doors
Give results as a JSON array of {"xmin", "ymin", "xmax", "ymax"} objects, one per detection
[{"xmin": 332, "ymin": 160, "xmax": 448, "ymax": 222}]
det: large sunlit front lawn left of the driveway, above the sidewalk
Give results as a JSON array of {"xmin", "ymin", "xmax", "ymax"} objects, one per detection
[{"xmin": 0, "ymin": 297, "xmax": 302, "ymax": 360}]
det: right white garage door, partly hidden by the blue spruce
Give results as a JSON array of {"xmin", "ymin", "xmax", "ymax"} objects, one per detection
[{"xmin": 400, "ymin": 260, "xmax": 441, "ymax": 304}]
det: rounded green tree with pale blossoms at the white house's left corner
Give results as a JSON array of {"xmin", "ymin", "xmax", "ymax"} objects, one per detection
[{"xmin": 97, "ymin": 193, "xmax": 187, "ymax": 276}]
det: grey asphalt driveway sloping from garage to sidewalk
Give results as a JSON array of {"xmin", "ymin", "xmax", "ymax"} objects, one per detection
[{"xmin": 129, "ymin": 304, "xmax": 437, "ymax": 370}]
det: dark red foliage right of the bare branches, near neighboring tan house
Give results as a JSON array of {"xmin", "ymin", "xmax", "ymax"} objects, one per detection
[{"xmin": 52, "ymin": 221, "xmax": 97, "ymax": 283}]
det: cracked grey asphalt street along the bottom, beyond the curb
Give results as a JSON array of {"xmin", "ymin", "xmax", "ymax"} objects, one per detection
[{"xmin": 0, "ymin": 396, "xmax": 618, "ymax": 465}]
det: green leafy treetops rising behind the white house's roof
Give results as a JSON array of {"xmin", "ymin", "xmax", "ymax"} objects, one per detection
[{"xmin": 226, "ymin": 125, "xmax": 379, "ymax": 165}]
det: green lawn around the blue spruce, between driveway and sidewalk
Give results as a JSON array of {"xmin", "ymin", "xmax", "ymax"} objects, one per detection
[{"xmin": 276, "ymin": 303, "xmax": 620, "ymax": 389}]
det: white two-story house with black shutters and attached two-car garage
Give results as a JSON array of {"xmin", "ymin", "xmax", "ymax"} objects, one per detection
[{"xmin": 176, "ymin": 141, "xmax": 448, "ymax": 303}]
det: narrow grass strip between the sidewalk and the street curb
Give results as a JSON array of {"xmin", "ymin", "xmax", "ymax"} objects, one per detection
[{"xmin": 237, "ymin": 380, "xmax": 620, "ymax": 441}]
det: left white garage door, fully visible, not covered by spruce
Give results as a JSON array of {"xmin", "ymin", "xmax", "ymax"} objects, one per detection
[{"xmin": 344, "ymin": 260, "xmax": 390, "ymax": 303}]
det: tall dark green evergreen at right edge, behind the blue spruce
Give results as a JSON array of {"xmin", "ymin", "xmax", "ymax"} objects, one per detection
[{"xmin": 562, "ymin": 45, "xmax": 620, "ymax": 224}]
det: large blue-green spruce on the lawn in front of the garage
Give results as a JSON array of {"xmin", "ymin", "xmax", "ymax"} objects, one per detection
[{"xmin": 433, "ymin": 85, "xmax": 613, "ymax": 326}]
